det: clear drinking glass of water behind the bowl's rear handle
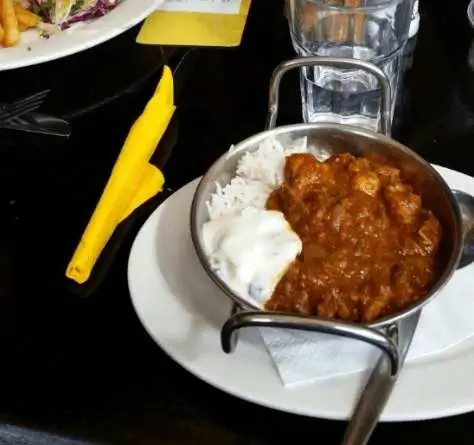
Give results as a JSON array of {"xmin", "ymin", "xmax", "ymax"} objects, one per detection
[{"xmin": 286, "ymin": 0, "xmax": 414, "ymax": 130}]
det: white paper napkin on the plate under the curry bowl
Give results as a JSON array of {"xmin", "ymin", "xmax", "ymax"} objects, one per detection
[{"xmin": 260, "ymin": 264, "xmax": 474, "ymax": 386}]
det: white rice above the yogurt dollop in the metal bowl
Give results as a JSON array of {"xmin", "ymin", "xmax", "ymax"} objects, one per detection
[{"xmin": 206, "ymin": 138, "xmax": 308, "ymax": 220}]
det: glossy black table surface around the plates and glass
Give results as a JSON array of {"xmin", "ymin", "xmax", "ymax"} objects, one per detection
[{"xmin": 0, "ymin": 0, "xmax": 474, "ymax": 445}]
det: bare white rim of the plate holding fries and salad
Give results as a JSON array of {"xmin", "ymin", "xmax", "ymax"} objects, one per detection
[{"xmin": 0, "ymin": 0, "xmax": 165, "ymax": 71}]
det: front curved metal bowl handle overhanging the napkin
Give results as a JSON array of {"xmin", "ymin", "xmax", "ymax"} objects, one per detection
[{"xmin": 221, "ymin": 305, "xmax": 400, "ymax": 376}]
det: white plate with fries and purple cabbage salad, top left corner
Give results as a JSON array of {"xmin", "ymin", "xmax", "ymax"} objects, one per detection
[{"xmin": 0, "ymin": 0, "xmax": 164, "ymax": 71}]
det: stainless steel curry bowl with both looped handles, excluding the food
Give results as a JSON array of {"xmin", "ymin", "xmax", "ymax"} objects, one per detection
[{"xmin": 191, "ymin": 57, "xmax": 474, "ymax": 443}]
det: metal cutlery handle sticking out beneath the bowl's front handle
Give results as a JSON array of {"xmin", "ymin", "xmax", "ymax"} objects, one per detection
[{"xmin": 342, "ymin": 311, "xmax": 421, "ymax": 445}]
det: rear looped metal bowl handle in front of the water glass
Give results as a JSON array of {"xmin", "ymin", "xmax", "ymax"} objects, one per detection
[{"xmin": 266, "ymin": 56, "xmax": 392, "ymax": 136}]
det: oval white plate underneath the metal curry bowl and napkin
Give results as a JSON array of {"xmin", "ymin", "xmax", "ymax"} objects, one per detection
[{"xmin": 128, "ymin": 168, "xmax": 474, "ymax": 421}]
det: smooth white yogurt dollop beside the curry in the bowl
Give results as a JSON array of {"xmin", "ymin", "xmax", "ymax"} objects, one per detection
[{"xmin": 202, "ymin": 207, "xmax": 303, "ymax": 306}]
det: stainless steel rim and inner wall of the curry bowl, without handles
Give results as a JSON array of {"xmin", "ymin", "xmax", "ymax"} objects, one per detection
[{"xmin": 191, "ymin": 119, "xmax": 463, "ymax": 328}]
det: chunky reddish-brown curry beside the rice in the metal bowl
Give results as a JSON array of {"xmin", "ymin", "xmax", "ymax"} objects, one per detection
[{"xmin": 266, "ymin": 153, "xmax": 442, "ymax": 323}]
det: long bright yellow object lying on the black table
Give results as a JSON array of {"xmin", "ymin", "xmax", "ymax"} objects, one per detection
[{"xmin": 66, "ymin": 66, "xmax": 176, "ymax": 284}]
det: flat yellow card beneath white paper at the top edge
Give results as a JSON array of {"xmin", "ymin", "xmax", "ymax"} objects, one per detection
[{"xmin": 137, "ymin": 0, "xmax": 251, "ymax": 47}]
